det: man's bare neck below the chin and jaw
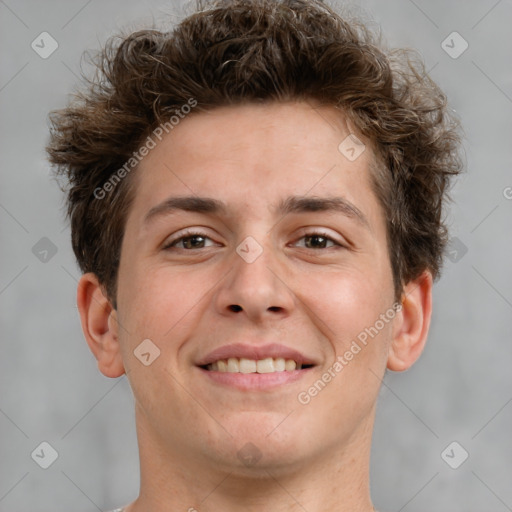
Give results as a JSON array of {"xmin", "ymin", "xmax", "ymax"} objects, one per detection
[{"xmin": 124, "ymin": 407, "xmax": 374, "ymax": 512}]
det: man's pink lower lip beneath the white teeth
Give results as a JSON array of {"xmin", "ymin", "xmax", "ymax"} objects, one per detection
[{"xmin": 199, "ymin": 366, "xmax": 314, "ymax": 391}]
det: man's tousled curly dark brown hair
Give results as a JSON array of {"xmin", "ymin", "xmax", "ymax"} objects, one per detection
[{"xmin": 47, "ymin": 0, "xmax": 462, "ymax": 307}]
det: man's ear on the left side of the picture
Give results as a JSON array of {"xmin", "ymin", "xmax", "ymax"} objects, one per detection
[{"xmin": 77, "ymin": 272, "xmax": 125, "ymax": 377}]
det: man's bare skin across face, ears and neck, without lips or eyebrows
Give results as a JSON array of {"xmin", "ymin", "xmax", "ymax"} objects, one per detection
[{"xmin": 77, "ymin": 102, "xmax": 432, "ymax": 512}]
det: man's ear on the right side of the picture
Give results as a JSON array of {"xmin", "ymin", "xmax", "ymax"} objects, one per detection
[{"xmin": 387, "ymin": 271, "xmax": 433, "ymax": 372}]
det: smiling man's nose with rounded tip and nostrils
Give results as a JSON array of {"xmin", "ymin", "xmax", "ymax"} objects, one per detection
[{"xmin": 214, "ymin": 240, "xmax": 295, "ymax": 323}]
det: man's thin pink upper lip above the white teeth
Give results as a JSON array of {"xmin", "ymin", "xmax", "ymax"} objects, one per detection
[{"xmin": 196, "ymin": 343, "xmax": 316, "ymax": 366}]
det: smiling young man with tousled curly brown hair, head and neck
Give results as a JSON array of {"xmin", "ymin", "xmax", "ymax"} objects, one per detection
[{"xmin": 49, "ymin": 0, "xmax": 460, "ymax": 512}]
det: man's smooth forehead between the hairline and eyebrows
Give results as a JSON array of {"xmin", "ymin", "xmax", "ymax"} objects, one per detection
[{"xmin": 124, "ymin": 102, "xmax": 380, "ymax": 226}]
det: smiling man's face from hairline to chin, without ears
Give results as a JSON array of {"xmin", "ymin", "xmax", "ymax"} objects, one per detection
[{"xmin": 113, "ymin": 102, "xmax": 395, "ymax": 471}]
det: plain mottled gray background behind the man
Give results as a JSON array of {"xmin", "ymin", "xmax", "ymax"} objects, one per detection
[{"xmin": 0, "ymin": 0, "xmax": 512, "ymax": 512}]
